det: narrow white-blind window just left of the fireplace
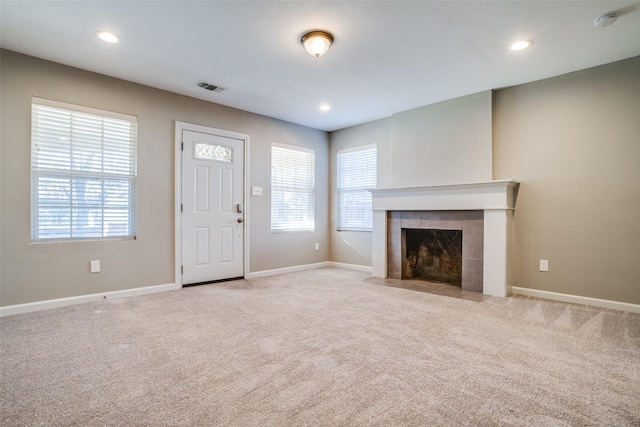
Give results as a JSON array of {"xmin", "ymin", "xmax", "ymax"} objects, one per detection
[{"xmin": 338, "ymin": 145, "xmax": 377, "ymax": 231}]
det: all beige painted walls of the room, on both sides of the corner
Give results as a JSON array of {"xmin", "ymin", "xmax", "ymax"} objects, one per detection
[{"xmin": 0, "ymin": 51, "xmax": 640, "ymax": 306}]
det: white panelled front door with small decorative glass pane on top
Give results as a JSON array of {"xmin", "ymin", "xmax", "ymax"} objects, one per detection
[{"xmin": 181, "ymin": 129, "xmax": 244, "ymax": 284}]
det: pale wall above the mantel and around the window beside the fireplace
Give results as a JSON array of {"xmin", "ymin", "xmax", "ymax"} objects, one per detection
[{"xmin": 330, "ymin": 91, "xmax": 492, "ymax": 266}]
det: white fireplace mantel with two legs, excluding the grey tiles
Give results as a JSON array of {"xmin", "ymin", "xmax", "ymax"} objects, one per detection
[{"xmin": 370, "ymin": 179, "xmax": 520, "ymax": 297}]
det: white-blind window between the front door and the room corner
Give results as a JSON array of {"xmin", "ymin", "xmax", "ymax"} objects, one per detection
[{"xmin": 271, "ymin": 143, "xmax": 315, "ymax": 232}]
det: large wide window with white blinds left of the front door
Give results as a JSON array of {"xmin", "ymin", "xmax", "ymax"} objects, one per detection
[{"xmin": 31, "ymin": 98, "xmax": 137, "ymax": 242}]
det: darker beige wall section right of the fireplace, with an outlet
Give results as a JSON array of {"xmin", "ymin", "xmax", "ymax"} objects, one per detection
[{"xmin": 493, "ymin": 57, "xmax": 640, "ymax": 304}]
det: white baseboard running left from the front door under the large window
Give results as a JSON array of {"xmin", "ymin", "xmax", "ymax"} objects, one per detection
[{"xmin": 0, "ymin": 283, "xmax": 178, "ymax": 317}]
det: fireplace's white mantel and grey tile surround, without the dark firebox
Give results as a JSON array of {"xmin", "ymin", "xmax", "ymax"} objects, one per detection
[{"xmin": 371, "ymin": 179, "xmax": 519, "ymax": 297}]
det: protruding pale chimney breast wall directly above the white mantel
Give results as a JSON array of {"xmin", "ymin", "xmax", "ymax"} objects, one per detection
[{"xmin": 388, "ymin": 91, "xmax": 491, "ymax": 188}]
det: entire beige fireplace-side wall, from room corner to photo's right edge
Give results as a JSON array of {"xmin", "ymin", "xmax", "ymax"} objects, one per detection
[{"xmin": 330, "ymin": 57, "xmax": 640, "ymax": 304}]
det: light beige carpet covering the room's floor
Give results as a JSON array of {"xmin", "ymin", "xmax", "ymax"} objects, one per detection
[{"xmin": 0, "ymin": 268, "xmax": 640, "ymax": 426}]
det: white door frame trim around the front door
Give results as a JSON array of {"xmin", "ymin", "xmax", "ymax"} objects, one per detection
[{"xmin": 173, "ymin": 120, "xmax": 251, "ymax": 289}]
